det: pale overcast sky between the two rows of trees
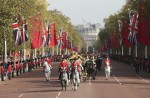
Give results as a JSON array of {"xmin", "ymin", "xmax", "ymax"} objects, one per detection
[{"xmin": 47, "ymin": 0, "xmax": 126, "ymax": 26}]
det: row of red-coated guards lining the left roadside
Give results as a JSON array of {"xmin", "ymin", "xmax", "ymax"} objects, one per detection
[{"xmin": 0, "ymin": 57, "xmax": 45, "ymax": 81}]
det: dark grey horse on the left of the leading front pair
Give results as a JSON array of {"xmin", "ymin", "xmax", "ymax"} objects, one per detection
[{"xmin": 60, "ymin": 70, "xmax": 68, "ymax": 91}]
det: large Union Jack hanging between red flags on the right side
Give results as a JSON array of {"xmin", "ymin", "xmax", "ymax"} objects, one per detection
[{"xmin": 128, "ymin": 11, "xmax": 139, "ymax": 44}]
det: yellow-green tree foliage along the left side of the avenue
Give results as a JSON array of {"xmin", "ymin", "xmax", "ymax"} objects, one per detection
[{"xmin": 0, "ymin": 0, "xmax": 84, "ymax": 54}]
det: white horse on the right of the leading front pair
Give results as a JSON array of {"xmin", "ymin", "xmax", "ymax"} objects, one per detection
[{"xmin": 72, "ymin": 65, "xmax": 80, "ymax": 91}]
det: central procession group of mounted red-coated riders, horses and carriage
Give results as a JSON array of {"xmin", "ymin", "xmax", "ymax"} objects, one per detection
[{"xmin": 55, "ymin": 53, "xmax": 102, "ymax": 90}]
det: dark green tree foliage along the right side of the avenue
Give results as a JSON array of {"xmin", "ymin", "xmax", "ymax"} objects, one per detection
[{"xmin": 97, "ymin": 0, "xmax": 150, "ymax": 55}]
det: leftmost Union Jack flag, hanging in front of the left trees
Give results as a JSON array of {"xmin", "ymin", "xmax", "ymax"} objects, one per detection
[{"xmin": 12, "ymin": 22, "xmax": 22, "ymax": 45}]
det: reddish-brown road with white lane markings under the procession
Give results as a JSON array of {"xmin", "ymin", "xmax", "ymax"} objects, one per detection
[{"xmin": 0, "ymin": 61, "xmax": 150, "ymax": 98}]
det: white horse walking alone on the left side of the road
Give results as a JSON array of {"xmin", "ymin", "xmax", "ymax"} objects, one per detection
[{"xmin": 43, "ymin": 61, "xmax": 52, "ymax": 81}]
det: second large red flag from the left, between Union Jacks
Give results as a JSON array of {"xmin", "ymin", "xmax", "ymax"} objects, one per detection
[{"xmin": 49, "ymin": 23, "xmax": 57, "ymax": 47}]
